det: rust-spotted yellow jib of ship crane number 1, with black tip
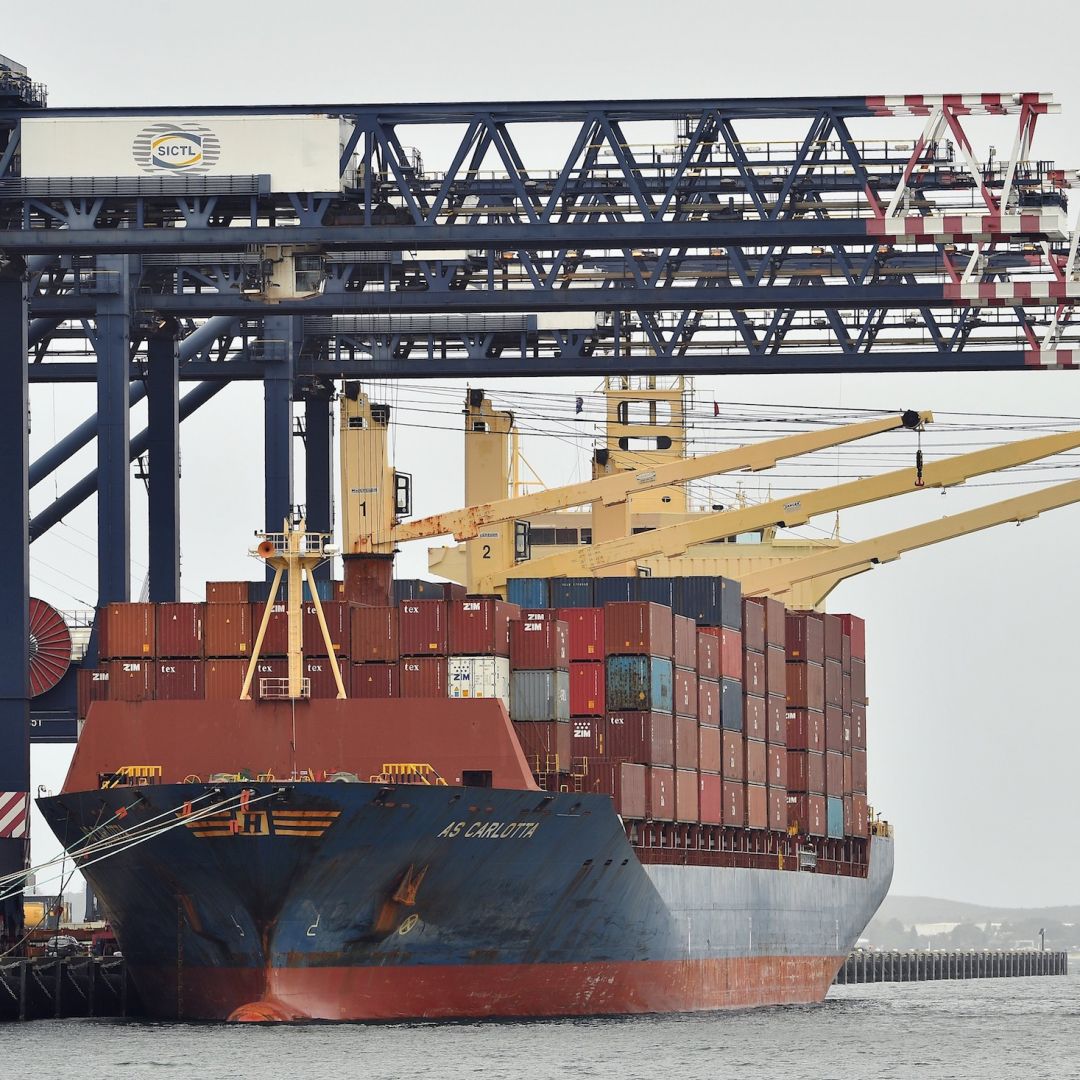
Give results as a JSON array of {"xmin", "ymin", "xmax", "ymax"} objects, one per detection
[{"xmin": 393, "ymin": 410, "xmax": 933, "ymax": 542}]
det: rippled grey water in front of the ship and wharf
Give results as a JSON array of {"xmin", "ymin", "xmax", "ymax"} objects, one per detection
[{"xmin": 0, "ymin": 974, "xmax": 1080, "ymax": 1080}]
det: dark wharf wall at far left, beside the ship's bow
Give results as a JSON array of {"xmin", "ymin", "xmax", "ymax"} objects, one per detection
[{"xmin": 0, "ymin": 956, "xmax": 139, "ymax": 1022}]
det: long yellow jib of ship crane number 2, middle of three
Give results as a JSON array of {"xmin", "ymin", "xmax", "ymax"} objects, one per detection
[{"xmin": 490, "ymin": 432, "xmax": 1080, "ymax": 592}]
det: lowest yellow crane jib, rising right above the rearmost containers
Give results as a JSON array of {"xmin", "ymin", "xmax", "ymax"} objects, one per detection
[{"xmin": 742, "ymin": 480, "xmax": 1080, "ymax": 608}]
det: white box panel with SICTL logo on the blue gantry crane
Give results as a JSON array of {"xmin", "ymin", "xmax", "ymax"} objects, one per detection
[{"xmin": 21, "ymin": 116, "xmax": 341, "ymax": 191}]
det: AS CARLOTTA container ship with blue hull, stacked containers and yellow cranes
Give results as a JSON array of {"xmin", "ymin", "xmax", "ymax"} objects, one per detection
[{"xmin": 39, "ymin": 379, "xmax": 1080, "ymax": 1022}]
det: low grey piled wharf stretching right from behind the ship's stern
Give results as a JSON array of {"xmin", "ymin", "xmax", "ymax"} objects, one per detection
[{"xmin": 834, "ymin": 949, "xmax": 1069, "ymax": 986}]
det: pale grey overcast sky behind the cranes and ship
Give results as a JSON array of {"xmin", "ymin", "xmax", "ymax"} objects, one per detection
[{"xmin": 8, "ymin": 0, "xmax": 1080, "ymax": 905}]
